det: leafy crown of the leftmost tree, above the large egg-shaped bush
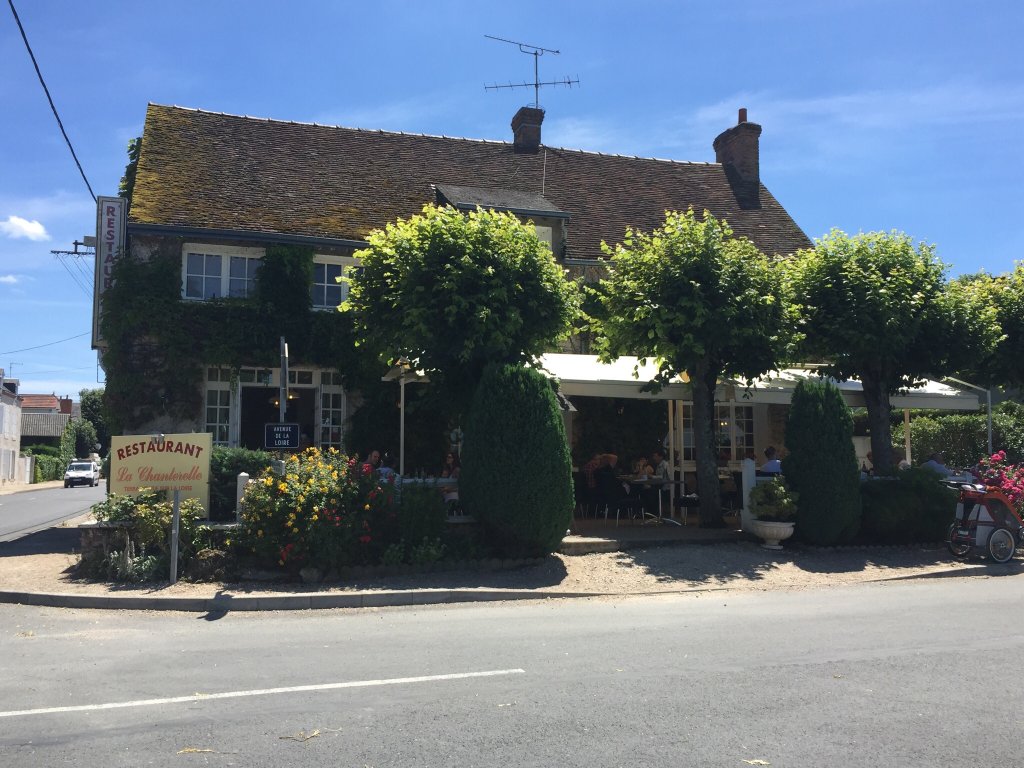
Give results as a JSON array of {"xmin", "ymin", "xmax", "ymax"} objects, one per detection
[{"xmin": 342, "ymin": 205, "xmax": 578, "ymax": 403}]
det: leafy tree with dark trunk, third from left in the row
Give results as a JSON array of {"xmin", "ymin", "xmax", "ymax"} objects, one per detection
[{"xmin": 788, "ymin": 229, "xmax": 998, "ymax": 475}]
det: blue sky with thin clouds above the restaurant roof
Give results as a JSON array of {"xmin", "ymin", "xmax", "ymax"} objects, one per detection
[{"xmin": 0, "ymin": 0, "xmax": 1024, "ymax": 399}]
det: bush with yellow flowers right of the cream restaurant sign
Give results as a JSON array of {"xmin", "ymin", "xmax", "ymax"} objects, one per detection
[{"xmin": 239, "ymin": 449, "xmax": 395, "ymax": 569}]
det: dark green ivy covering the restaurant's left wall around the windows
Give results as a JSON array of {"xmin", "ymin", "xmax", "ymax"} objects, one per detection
[{"xmin": 100, "ymin": 238, "xmax": 381, "ymax": 434}]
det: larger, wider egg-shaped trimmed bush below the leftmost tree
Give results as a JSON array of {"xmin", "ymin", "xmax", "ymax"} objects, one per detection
[{"xmin": 459, "ymin": 365, "xmax": 574, "ymax": 557}]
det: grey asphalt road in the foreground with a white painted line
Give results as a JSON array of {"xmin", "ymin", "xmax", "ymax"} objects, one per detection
[{"xmin": 0, "ymin": 571, "xmax": 1024, "ymax": 768}]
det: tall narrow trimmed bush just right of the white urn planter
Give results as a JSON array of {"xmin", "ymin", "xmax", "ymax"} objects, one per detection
[{"xmin": 782, "ymin": 381, "xmax": 860, "ymax": 546}]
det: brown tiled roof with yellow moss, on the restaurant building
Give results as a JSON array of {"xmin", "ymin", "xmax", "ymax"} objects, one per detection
[{"xmin": 130, "ymin": 104, "xmax": 810, "ymax": 258}]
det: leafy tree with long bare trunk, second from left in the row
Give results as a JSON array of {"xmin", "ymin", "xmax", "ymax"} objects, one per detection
[{"xmin": 598, "ymin": 209, "xmax": 788, "ymax": 526}]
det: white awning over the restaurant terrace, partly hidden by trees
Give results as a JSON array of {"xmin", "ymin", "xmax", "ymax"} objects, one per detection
[{"xmin": 541, "ymin": 353, "xmax": 979, "ymax": 411}]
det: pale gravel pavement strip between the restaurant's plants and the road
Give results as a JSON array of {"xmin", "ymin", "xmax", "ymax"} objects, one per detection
[{"xmin": 0, "ymin": 543, "xmax": 1024, "ymax": 597}]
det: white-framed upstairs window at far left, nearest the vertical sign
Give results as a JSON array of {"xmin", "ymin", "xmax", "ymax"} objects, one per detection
[{"xmin": 181, "ymin": 243, "xmax": 264, "ymax": 301}]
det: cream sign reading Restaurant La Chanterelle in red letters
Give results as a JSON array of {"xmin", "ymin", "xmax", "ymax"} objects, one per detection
[{"xmin": 111, "ymin": 432, "xmax": 213, "ymax": 514}]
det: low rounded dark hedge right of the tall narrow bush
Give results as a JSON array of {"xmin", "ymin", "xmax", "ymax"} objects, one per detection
[{"xmin": 860, "ymin": 468, "xmax": 956, "ymax": 544}]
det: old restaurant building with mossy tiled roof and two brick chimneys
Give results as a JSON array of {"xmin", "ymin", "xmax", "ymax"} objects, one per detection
[{"xmin": 103, "ymin": 104, "xmax": 811, "ymax": 460}]
